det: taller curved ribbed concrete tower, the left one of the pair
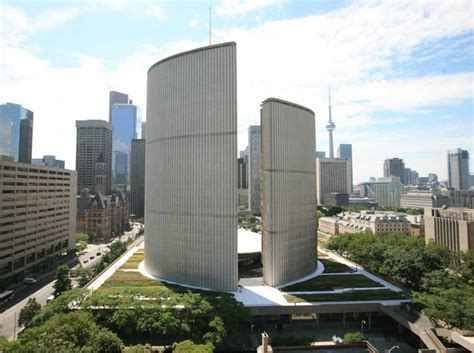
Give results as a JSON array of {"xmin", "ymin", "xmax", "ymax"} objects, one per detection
[{"xmin": 145, "ymin": 43, "xmax": 237, "ymax": 290}]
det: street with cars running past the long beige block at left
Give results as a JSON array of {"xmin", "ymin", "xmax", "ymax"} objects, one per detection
[{"xmin": 0, "ymin": 223, "xmax": 140, "ymax": 340}]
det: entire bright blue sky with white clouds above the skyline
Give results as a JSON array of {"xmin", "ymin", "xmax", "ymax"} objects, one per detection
[{"xmin": 0, "ymin": 0, "xmax": 474, "ymax": 182}]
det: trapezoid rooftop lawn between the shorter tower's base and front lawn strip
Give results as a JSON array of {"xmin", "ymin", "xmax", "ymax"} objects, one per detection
[{"xmin": 282, "ymin": 274, "xmax": 383, "ymax": 292}]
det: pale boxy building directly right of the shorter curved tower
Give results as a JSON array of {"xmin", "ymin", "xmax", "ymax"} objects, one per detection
[{"xmin": 316, "ymin": 158, "xmax": 348, "ymax": 205}]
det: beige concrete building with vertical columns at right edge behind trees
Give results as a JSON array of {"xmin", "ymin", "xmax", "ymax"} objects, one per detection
[{"xmin": 425, "ymin": 207, "xmax": 474, "ymax": 251}]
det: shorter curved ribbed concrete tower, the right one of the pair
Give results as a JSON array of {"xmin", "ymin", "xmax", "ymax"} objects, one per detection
[{"xmin": 261, "ymin": 98, "xmax": 317, "ymax": 286}]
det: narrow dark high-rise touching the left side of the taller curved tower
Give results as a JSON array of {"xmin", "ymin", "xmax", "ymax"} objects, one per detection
[{"xmin": 130, "ymin": 139, "xmax": 146, "ymax": 218}]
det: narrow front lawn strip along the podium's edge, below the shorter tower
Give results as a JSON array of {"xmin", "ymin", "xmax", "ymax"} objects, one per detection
[{"xmin": 284, "ymin": 289, "xmax": 408, "ymax": 303}]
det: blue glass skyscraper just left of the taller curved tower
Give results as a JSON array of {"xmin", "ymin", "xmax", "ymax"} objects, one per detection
[{"xmin": 112, "ymin": 104, "xmax": 141, "ymax": 191}]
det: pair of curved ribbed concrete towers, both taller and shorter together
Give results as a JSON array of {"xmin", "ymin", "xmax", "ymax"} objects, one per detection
[{"xmin": 145, "ymin": 43, "xmax": 317, "ymax": 291}]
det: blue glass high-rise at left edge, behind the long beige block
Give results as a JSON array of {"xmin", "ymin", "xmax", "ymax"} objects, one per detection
[{"xmin": 0, "ymin": 103, "xmax": 33, "ymax": 163}]
